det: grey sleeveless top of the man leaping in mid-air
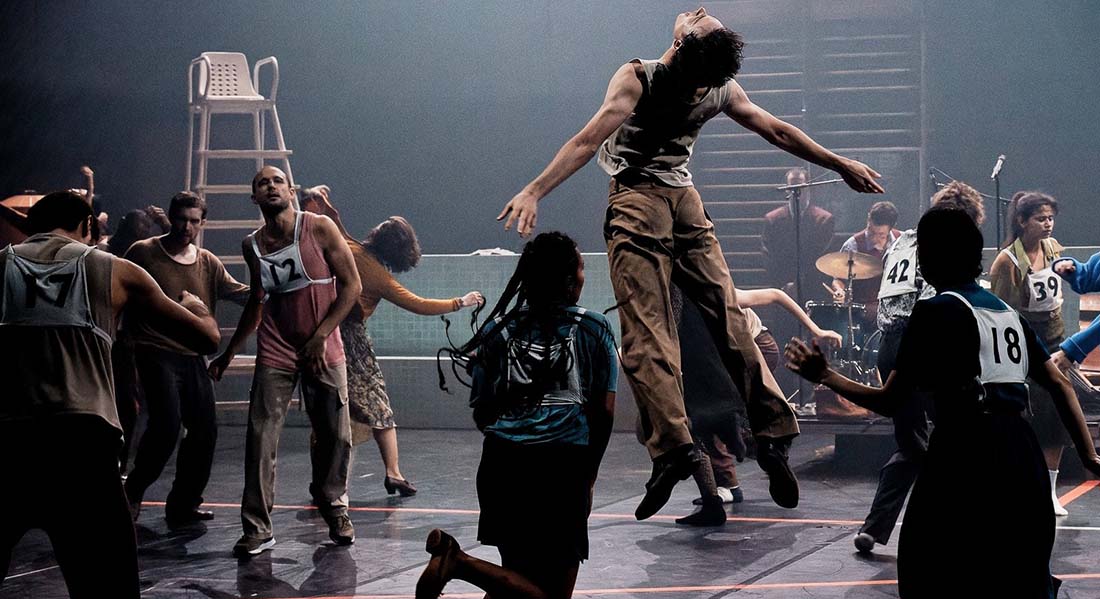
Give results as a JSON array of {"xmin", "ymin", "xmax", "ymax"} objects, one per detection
[{"xmin": 596, "ymin": 58, "xmax": 730, "ymax": 187}]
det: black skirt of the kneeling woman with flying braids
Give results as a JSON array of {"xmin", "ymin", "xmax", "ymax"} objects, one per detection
[{"xmin": 477, "ymin": 434, "xmax": 591, "ymax": 566}]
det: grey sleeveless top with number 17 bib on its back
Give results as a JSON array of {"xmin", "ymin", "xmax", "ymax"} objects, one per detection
[{"xmin": 0, "ymin": 234, "xmax": 121, "ymax": 430}]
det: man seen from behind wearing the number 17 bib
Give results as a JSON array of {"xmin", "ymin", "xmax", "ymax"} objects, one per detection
[{"xmin": 0, "ymin": 191, "xmax": 220, "ymax": 599}]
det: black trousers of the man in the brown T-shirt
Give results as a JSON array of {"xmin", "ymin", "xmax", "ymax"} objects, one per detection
[{"xmin": 127, "ymin": 345, "xmax": 218, "ymax": 512}]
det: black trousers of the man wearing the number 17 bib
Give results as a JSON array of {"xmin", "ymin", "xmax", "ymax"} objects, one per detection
[{"xmin": 0, "ymin": 414, "xmax": 140, "ymax": 599}]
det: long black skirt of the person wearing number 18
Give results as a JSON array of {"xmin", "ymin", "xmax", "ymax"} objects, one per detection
[{"xmin": 898, "ymin": 412, "xmax": 1055, "ymax": 599}]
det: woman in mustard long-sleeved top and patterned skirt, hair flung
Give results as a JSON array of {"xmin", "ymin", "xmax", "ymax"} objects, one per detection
[{"xmin": 301, "ymin": 185, "xmax": 485, "ymax": 497}]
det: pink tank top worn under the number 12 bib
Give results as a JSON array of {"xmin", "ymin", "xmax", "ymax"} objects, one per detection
[{"xmin": 253, "ymin": 212, "xmax": 344, "ymax": 370}]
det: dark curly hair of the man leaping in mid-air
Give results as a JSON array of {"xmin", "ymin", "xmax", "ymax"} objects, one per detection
[{"xmin": 670, "ymin": 27, "xmax": 745, "ymax": 87}]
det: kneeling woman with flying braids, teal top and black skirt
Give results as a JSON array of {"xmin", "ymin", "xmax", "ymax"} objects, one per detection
[{"xmin": 416, "ymin": 233, "xmax": 618, "ymax": 599}]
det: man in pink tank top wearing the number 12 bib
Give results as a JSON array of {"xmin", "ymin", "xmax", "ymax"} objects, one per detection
[{"xmin": 210, "ymin": 166, "xmax": 362, "ymax": 557}]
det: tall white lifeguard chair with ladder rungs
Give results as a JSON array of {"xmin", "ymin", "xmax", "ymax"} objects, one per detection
[{"xmin": 184, "ymin": 52, "xmax": 294, "ymax": 229}]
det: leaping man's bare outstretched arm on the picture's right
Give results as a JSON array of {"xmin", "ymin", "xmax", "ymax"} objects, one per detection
[{"xmin": 725, "ymin": 81, "xmax": 883, "ymax": 193}]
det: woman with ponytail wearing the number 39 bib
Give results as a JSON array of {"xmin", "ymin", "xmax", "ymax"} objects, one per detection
[{"xmin": 989, "ymin": 191, "xmax": 1069, "ymax": 515}]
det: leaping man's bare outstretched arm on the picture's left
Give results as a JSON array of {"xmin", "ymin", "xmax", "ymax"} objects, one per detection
[{"xmin": 496, "ymin": 63, "xmax": 641, "ymax": 236}]
